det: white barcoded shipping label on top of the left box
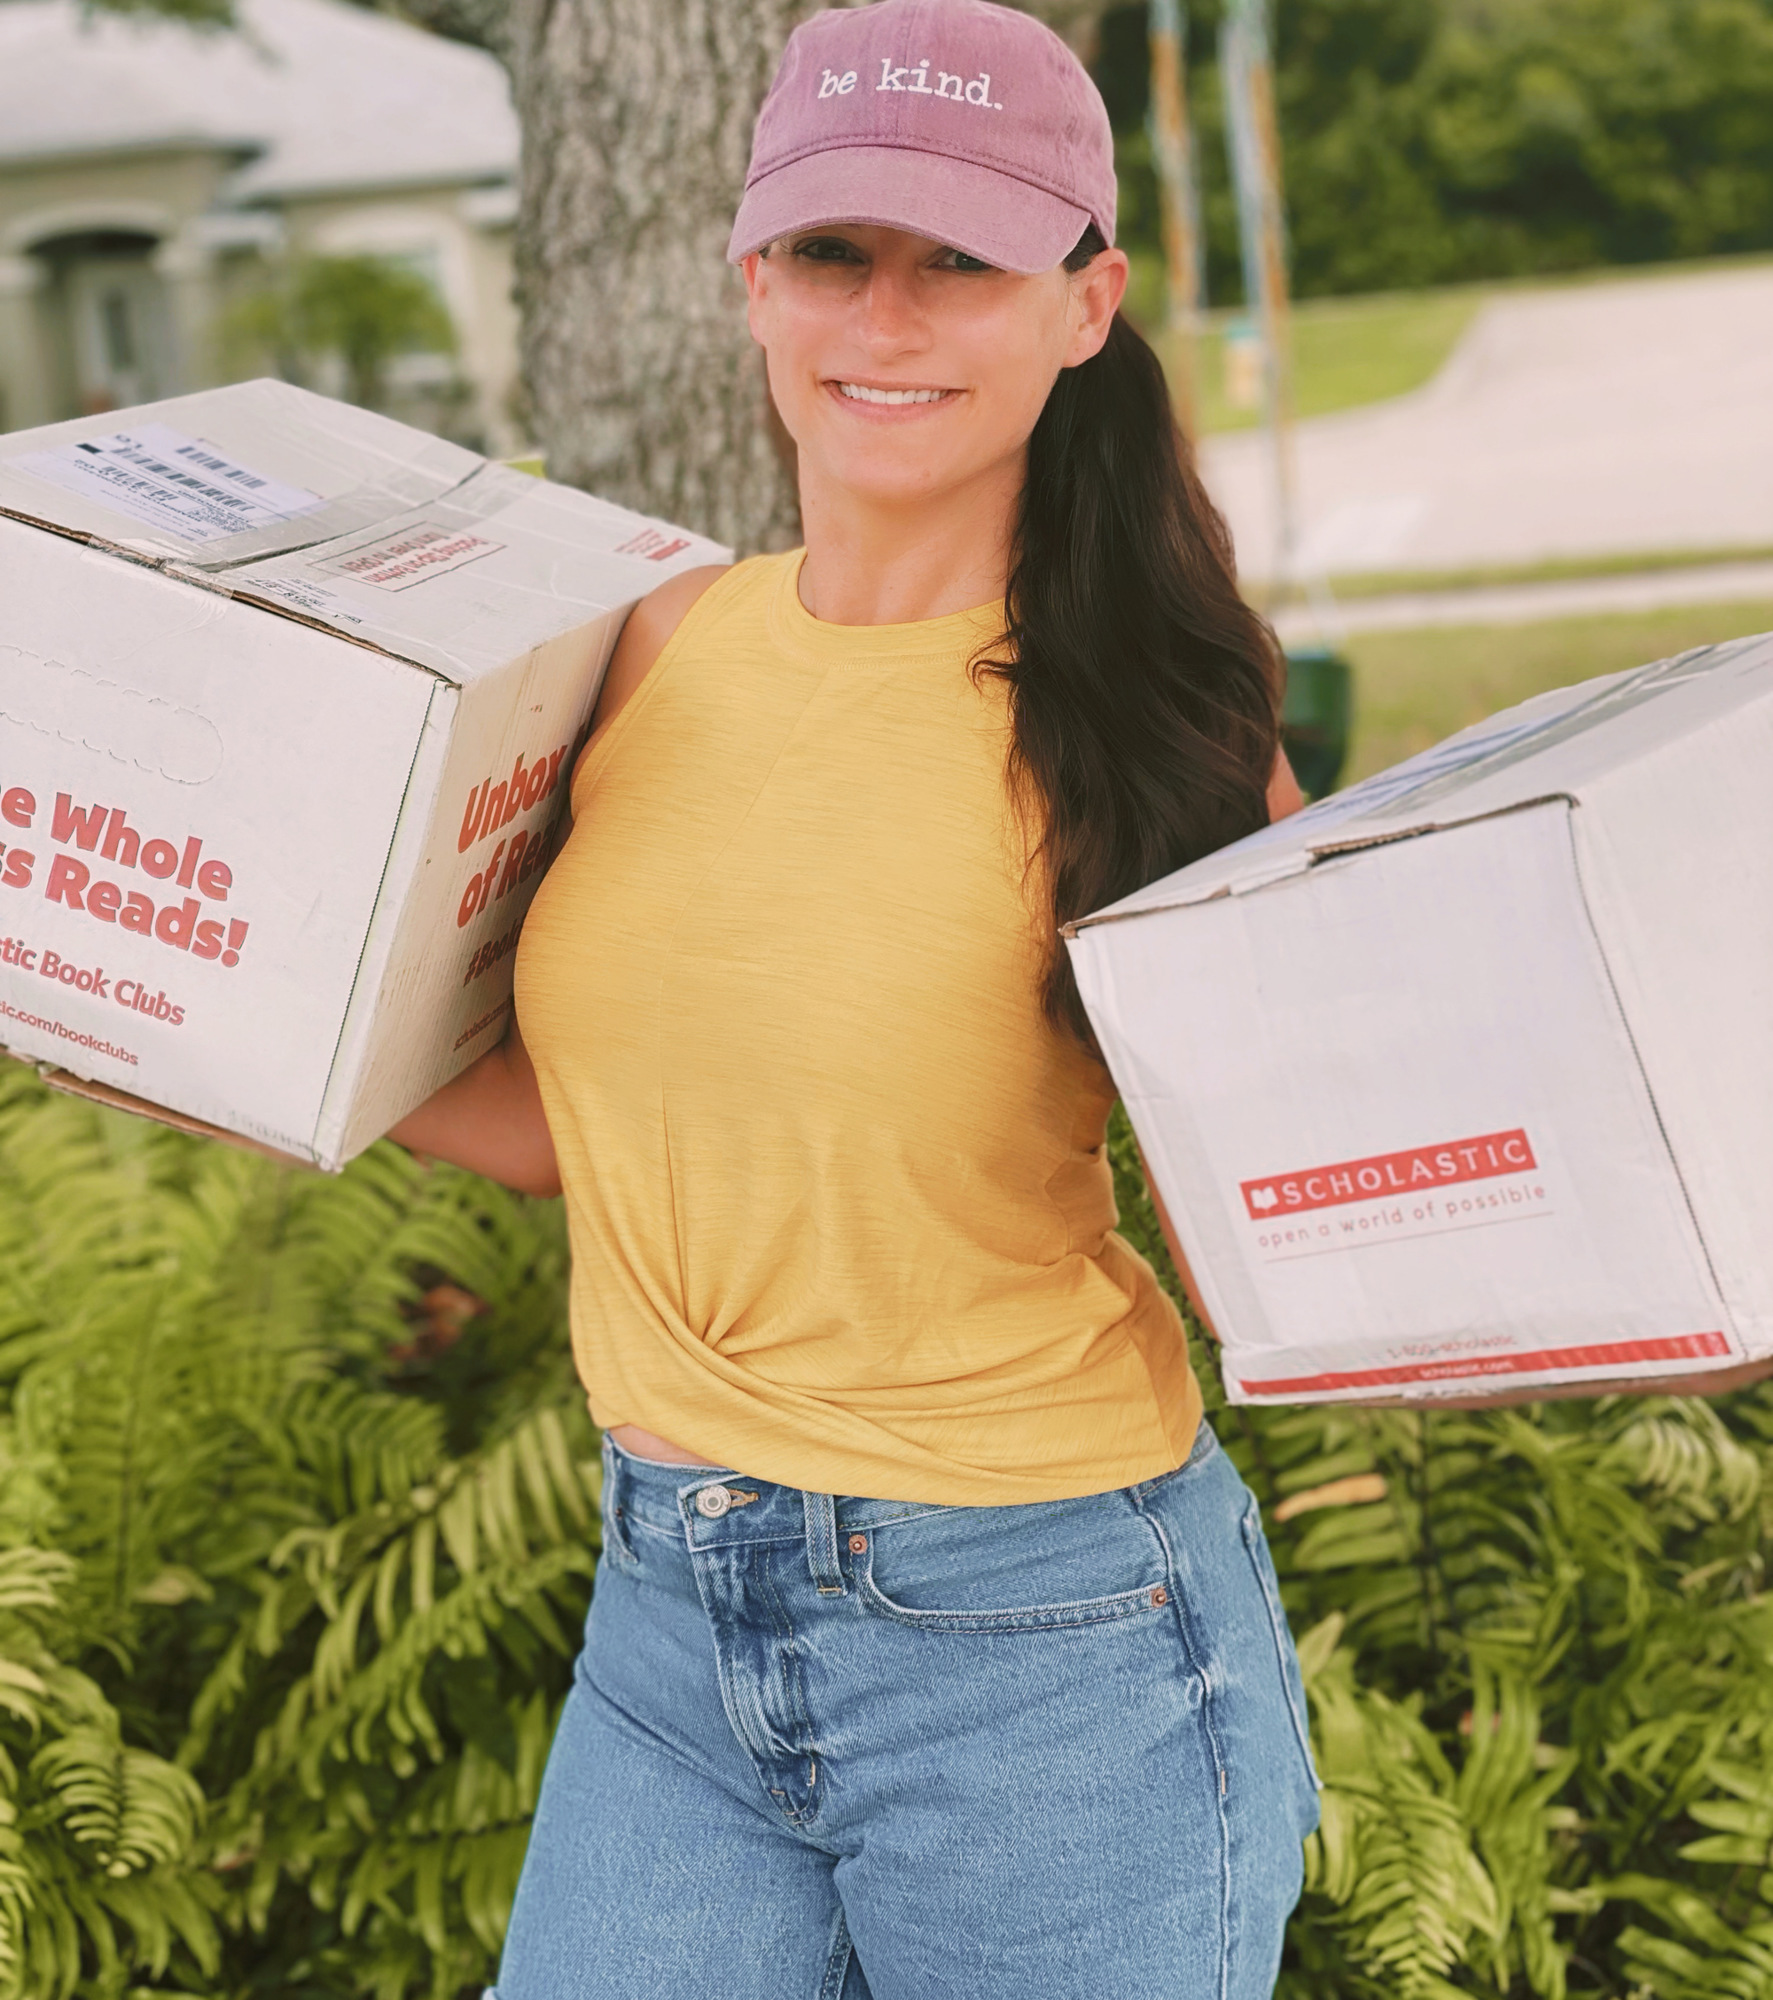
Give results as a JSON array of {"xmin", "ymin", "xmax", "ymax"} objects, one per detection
[{"xmin": 10, "ymin": 424, "xmax": 322, "ymax": 544}]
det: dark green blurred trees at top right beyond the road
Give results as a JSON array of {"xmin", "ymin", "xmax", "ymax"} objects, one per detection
[{"xmin": 1095, "ymin": 0, "xmax": 1773, "ymax": 302}]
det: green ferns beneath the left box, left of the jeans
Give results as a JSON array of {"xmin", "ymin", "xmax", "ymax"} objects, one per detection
[{"xmin": 0, "ymin": 1066, "xmax": 596, "ymax": 2000}]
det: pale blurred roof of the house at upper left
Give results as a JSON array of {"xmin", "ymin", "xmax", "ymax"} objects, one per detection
[{"xmin": 0, "ymin": 0, "xmax": 518, "ymax": 202}]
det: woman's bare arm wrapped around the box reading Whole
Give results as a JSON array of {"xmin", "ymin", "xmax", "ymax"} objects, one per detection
[{"xmin": 388, "ymin": 564, "xmax": 722, "ymax": 1194}]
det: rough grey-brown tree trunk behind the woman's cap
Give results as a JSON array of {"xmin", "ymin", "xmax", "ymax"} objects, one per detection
[{"xmin": 402, "ymin": 0, "xmax": 1099, "ymax": 554}]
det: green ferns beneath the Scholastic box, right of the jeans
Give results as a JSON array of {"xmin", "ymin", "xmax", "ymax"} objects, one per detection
[{"xmin": 1111, "ymin": 1114, "xmax": 1773, "ymax": 2000}]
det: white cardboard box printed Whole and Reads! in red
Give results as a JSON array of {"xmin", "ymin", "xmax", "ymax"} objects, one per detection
[{"xmin": 0, "ymin": 382, "xmax": 728, "ymax": 1168}]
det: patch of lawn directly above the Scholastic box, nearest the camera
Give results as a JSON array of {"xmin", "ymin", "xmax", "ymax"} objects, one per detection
[{"xmin": 1343, "ymin": 602, "xmax": 1773, "ymax": 784}]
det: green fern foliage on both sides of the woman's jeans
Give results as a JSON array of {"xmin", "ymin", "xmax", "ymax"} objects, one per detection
[{"xmin": 0, "ymin": 1066, "xmax": 1773, "ymax": 2000}]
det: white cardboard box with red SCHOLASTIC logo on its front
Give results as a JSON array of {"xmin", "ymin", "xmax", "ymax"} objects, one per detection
[{"xmin": 1071, "ymin": 636, "xmax": 1773, "ymax": 1402}]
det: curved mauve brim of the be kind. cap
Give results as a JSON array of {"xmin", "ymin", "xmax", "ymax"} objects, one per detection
[{"xmin": 726, "ymin": 146, "xmax": 1091, "ymax": 276}]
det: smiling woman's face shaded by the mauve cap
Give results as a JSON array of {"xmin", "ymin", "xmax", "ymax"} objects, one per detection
[{"xmin": 744, "ymin": 222, "xmax": 1127, "ymax": 506}]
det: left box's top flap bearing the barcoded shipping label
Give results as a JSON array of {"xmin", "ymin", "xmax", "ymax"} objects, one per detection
[{"xmin": 0, "ymin": 380, "xmax": 486, "ymax": 570}]
